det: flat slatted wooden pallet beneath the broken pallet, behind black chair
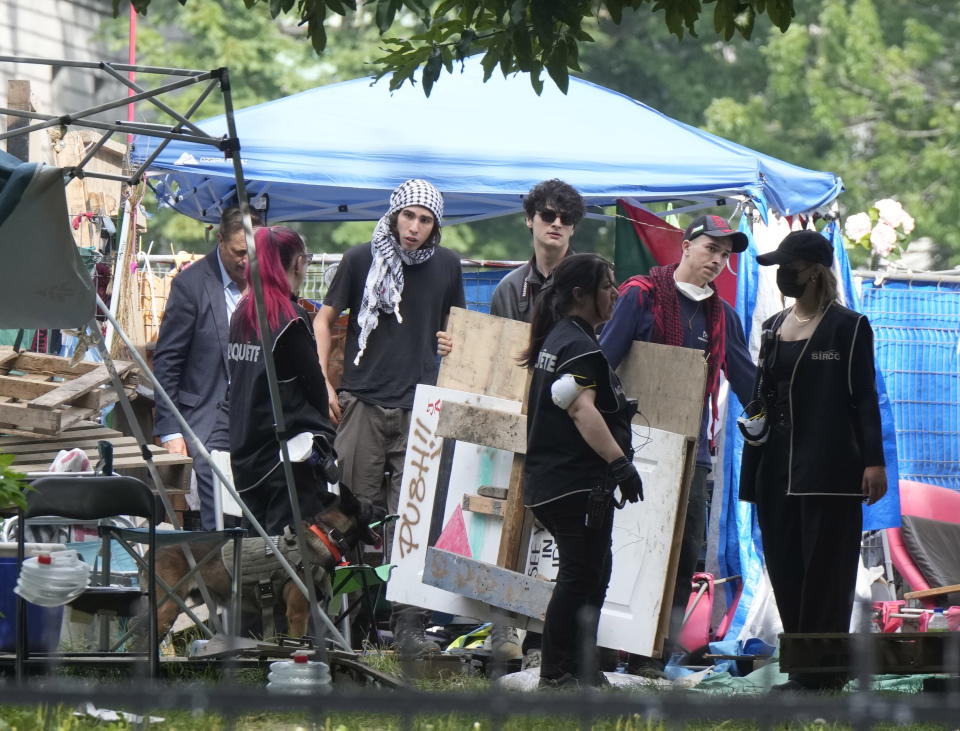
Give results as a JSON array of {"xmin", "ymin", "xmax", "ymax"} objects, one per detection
[{"xmin": 0, "ymin": 422, "xmax": 193, "ymax": 494}]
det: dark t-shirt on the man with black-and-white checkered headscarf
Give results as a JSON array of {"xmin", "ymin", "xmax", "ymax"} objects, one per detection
[{"xmin": 323, "ymin": 244, "xmax": 465, "ymax": 409}]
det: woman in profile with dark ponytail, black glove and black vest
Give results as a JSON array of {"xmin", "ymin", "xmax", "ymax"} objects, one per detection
[{"xmin": 520, "ymin": 254, "xmax": 643, "ymax": 688}]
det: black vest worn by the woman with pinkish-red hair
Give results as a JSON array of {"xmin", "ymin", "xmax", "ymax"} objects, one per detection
[{"xmin": 227, "ymin": 308, "xmax": 335, "ymax": 490}]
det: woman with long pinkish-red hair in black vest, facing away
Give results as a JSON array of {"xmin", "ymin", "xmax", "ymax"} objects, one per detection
[{"xmin": 227, "ymin": 226, "xmax": 335, "ymax": 535}]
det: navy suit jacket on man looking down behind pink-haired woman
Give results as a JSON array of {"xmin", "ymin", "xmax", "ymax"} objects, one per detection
[{"xmin": 153, "ymin": 248, "xmax": 230, "ymax": 443}]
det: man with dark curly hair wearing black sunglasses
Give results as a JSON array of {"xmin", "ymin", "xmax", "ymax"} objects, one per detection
[{"xmin": 490, "ymin": 178, "xmax": 583, "ymax": 322}]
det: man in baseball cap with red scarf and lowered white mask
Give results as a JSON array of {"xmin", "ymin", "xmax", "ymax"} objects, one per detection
[{"xmin": 600, "ymin": 216, "xmax": 756, "ymax": 660}]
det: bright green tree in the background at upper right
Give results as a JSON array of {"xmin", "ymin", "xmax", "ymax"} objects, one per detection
[{"xmin": 705, "ymin": 0, "xmax": 960, "ymax": 265}]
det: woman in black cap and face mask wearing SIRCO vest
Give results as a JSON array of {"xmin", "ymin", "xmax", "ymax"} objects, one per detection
[{"xmin": 740, "ymin": 231, "xmax": 887, "ymax": 690}]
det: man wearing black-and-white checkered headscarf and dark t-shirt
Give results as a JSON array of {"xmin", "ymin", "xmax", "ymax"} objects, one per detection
[{"xmin": 314, "ymin": 180, "xmax": 464, "ymax": 654}]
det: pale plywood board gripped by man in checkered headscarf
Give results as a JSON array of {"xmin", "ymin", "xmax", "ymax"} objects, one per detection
[{"xmin": 437, "ymin": 307, "xmax": 530, "ymax": 401}]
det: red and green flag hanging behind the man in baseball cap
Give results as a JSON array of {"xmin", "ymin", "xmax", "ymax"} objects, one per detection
[{"xmin": 613, "ymin": 200, "xmax": 739, "ymax": 305}]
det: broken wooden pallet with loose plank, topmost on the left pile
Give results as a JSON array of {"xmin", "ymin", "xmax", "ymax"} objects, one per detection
[{"xmin": 0, "ymin": 347, "xmax": 138, "ymax": 437}]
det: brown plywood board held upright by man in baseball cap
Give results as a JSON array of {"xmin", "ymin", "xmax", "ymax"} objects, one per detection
[{"xmin": 617, "ymin": 341, "xmax": 707, "ymax": 439}]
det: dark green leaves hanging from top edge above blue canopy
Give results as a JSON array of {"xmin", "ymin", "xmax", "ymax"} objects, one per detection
[{"xmin": 113, "ymin": 0, "xmax": 794, "ymax": 96}]
